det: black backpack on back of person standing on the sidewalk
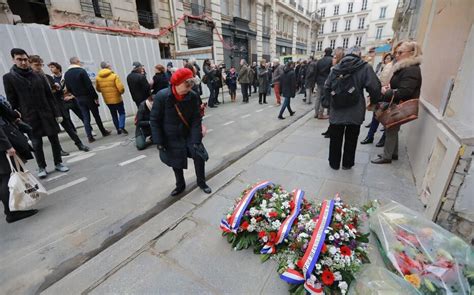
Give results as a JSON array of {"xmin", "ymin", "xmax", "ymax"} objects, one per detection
[{"xmin": 329, "ymin": 73, "xmax": 360, "ymax": 109}]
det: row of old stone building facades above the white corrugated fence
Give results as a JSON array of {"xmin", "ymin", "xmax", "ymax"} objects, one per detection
[{"xmin": 0, "ymin": 0, "xmax": 320, "ymax": 65}]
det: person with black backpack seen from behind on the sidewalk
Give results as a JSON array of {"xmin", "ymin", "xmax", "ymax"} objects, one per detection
[{"xmin": 324, "ymin": 46, "xmax": 382, "ymax": 170}]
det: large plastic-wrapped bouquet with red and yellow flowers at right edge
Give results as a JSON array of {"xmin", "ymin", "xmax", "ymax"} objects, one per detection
[{"xmin": 369, "ymin": 201, "xmax": 473, "ymax": 294}]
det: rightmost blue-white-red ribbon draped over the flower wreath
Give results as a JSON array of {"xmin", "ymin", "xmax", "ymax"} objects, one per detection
[{"xmin": 280, "ymin": 200, "xmax": 334, "ymax": 294}]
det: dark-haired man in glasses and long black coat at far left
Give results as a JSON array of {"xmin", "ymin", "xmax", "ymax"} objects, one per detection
[{"xmin": 3, "ymin": 48, "xmax": 69, "ymax": 178}]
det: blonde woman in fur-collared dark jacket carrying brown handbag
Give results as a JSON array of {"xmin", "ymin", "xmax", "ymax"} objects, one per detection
[{"xmin": 371, "ymin": 41, "xmax": 422, "ymax": 164}]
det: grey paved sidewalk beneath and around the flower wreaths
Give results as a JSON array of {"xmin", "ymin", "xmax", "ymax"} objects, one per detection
[{"xmin": 44, "ymin": 112, "xmax": 422, "ymax": 294}]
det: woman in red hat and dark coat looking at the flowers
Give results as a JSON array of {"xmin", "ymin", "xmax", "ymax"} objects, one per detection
[{"xmin": 150, "ymin": 68, "xmax": 211, "ymax": 196}]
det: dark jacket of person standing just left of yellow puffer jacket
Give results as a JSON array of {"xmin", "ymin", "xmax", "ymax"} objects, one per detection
[{"xmin": 64, "ymin": 66, "xmax": 99, "ymax": 100}]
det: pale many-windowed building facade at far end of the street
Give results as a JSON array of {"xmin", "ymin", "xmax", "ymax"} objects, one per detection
[{"xmin": 316, "ymin": 0, "xmax": 397, "ymax": 55}]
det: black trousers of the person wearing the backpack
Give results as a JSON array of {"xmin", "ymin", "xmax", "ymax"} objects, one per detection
[{"xmin": 329, "ymin": 124, "xmax": 360, "ymax": 169}]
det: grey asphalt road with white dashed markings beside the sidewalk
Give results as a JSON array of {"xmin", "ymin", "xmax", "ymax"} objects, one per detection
[{"xmin": 0, "ymin": 94, "xmax": 318, "ymax": 294}]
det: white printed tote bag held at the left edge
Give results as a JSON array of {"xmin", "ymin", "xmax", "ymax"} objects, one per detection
[{"xmin": 7, "ymin": 155, "xmax": 48, "ymax": 211}]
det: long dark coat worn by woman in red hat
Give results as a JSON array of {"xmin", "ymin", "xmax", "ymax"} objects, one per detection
[{"xmin": 150, "ymin": 88, "xmax": 202, "ymax": 169}]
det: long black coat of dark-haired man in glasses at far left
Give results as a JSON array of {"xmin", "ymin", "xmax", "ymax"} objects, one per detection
[{"xmin": 3, "ymin": 66, "xmax": 61, "ymax": 137}]
